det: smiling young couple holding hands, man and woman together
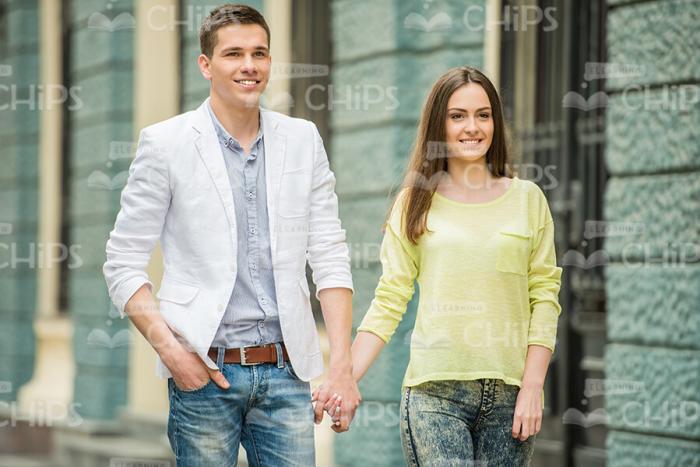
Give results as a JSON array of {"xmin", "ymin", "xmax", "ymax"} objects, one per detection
[{"xmin": 104, "ymin": 4, "xmax": 561, "ymax": 467}]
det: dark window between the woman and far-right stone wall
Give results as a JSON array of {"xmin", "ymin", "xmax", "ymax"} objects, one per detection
[{"xmin": 500, "ymin": 0, "xmax": 607, "ymax": 466}]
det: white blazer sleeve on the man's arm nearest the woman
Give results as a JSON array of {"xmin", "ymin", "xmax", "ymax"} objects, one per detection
[{"xmin": 307, "ymin": 122, "xmax": 353, "ymax": 298}]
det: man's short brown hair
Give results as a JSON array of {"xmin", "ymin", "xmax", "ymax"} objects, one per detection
[{"xmin": 199, "ymin": 3, "xmax": 270, "ymax": 58}]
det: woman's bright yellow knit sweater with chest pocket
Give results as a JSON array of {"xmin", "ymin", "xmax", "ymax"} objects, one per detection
[{"xmin": 358, "ymin": 178, "xmax": 561, "ymax": 386}]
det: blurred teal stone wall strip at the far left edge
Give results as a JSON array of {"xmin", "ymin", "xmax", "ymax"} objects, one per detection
[{"xmin": 0, "ymin": 0, "xmax": 40, "ymax": 410}]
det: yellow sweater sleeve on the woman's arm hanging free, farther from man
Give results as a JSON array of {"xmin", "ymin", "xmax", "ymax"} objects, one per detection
[{"xmin": 528, "ymin": 194, "xmax": 562, "ymax": 351}]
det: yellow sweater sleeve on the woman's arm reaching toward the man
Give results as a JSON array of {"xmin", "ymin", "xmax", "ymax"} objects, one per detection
[{"xmin": 358, "ymin": 194, "xmax": 418, "ymax": 343}]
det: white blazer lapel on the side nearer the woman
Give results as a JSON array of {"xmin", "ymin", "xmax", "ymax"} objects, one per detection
[{"xmin": 260, "ymin": 109, "xmax": 287, "ymax": 256}]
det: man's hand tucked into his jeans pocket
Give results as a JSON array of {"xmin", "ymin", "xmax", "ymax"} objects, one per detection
[{"xmin": 161, "ymin": 343, "xmax": 231, "ymax": 391}]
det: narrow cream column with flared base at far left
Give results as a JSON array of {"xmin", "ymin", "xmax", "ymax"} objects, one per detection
[{"xmin": 18, "ymin": 0, "xmax": 75, "ymax": 423}]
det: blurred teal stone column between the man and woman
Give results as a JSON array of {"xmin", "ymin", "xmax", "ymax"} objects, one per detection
[{"xmin": 332, "ymin": 0, "xmax": 492, "ymax": 466}]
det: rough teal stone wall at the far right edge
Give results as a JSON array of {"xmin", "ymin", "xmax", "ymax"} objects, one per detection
[{"xmin": 605, "ymin": 0, "xmax": 700, "ymax": 467}]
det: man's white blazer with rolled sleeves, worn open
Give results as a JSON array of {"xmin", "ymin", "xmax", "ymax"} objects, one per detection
[{"xmin": 103, "ymin": 100, "xmax": 352, "ymax": 381}]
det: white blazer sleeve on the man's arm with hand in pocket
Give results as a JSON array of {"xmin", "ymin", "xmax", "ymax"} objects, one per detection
[{"xmin": 102, "ymin": 130, "xmax": 171, "ymax": 318}]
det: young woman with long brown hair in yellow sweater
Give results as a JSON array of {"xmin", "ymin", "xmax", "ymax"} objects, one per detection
[{"xmin": 328, "ymin": 67, "xmax": 561, "ymax": 466}]
